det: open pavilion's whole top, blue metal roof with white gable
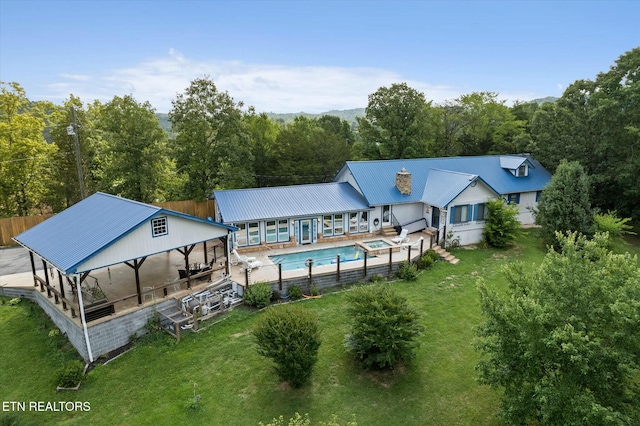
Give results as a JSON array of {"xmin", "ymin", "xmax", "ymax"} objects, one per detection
[{"xmin": 13, "ymin": 192, "xmax": 235, "ymax": 274}]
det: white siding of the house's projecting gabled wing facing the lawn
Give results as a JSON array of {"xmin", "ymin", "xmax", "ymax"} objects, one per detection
[{"xmin": 440, "ymin": 181, "xmax": 497, "ymax": 245}]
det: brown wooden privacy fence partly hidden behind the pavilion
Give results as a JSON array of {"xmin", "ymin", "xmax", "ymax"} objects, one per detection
[{"xmin": 0, "ymin": 200, "xmax": 215, "ymax": 246}]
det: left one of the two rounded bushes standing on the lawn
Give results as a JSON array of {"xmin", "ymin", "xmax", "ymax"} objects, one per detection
[{"xmin": 253, "ymin": 304, "xmax": 320, "ymax": 387}]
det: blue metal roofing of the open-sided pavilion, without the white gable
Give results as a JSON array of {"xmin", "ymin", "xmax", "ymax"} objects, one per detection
[{"xmin": 13, "ymin": 192, "xmax": 235, "ymax": 274}]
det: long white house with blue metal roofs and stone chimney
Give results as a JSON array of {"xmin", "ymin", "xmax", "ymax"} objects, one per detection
[{"xmin": 210, "ymin": 155, "xmax": 551, "ymax": 248}]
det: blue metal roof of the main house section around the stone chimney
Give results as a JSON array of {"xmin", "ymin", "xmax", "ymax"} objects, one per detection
[{"xmin": 338, "ymin": 155, "xmax": 551, "ymax": 206}]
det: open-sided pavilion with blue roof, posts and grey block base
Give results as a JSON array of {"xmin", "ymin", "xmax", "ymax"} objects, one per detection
[{"xmin": 14, "ymin": 192, "xmax": 236, "ymax": 362}]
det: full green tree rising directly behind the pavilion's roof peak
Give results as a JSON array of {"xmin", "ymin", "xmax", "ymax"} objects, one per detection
[{"xmin": 90, "ymin": 95, "xmax": 175, "ymax": 203}]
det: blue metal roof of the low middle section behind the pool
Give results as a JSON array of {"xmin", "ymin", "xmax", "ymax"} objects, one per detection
[{"xmin": 209, "ymin": 182, "xmax": 369, "ymax": 223}]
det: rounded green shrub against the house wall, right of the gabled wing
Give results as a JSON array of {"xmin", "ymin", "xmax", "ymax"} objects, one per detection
[{"xmin": 484, "ymin": 198, "xmax": 521, "ymax": 248}]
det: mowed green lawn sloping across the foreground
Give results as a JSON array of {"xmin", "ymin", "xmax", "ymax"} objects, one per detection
[{"xmin": 0, "ymin": 231, "xmax": 632, "ymax": 425}]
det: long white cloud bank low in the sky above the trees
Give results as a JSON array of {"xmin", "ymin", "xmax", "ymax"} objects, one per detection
[{"xmin": 49, "ymin": 49, "xmax": 470, "ymax": 113}]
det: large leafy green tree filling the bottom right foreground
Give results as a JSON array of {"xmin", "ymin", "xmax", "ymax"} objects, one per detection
[{"xmin": 477, "ymin": 233, "xmax": 640, "ymax": 425}]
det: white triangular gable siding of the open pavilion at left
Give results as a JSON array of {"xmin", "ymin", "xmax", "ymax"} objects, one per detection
[{"xmin": 77, "ymin": 215, "xmax": 228, "ymax": 271}]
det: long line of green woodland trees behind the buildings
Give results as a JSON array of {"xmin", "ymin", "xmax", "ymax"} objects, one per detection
[{"xmin": 0, "ymin": 48, "xmax": 640, "ymax": 219}]
